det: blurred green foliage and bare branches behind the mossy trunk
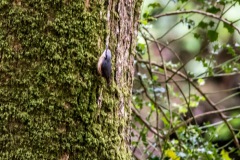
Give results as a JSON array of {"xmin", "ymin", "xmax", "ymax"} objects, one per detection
[{"xmin": 132, "ymin": 0, "xmax": 240, "ymax": 160}]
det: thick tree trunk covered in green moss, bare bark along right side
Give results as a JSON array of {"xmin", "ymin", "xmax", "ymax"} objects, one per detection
[{"xmin": 0, "ymin": 0, "xmax": 141, "ymax": 160}]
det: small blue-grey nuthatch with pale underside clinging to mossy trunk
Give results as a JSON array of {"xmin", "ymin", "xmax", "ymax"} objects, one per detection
[{"xmin": 97, "ymin": 46, "xmax": 112, "ymax": 85}]
